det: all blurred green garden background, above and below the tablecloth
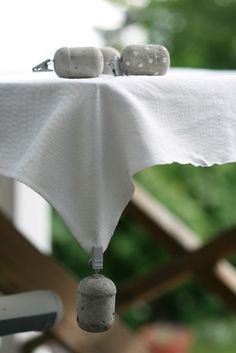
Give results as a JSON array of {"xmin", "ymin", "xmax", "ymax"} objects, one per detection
[{"xmin": 53, "ymin": 0, "xmax": 236, "ymax": 353}]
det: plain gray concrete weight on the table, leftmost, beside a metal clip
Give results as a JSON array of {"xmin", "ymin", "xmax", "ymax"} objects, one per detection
[{"xmin": 54, "ymin": 47, "xmax": 104, "ymax": 78}]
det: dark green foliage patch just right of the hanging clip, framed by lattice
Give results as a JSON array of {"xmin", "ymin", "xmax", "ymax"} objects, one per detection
[{"xmin": 104, "ymin": 217, "xmax": 169, "ymax": 284}]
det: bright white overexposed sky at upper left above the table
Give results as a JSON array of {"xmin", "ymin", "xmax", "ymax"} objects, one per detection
[{"xmin": 0, "ymin": 0, "xmax": 124, "ymax": 72}]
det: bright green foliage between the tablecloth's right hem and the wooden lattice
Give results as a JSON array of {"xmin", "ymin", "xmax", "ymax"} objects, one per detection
[{"xmin": 136, "ymin": 163, "xmax": 236, "ymax": 240}]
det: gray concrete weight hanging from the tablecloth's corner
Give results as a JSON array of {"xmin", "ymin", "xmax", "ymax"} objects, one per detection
[{"xmin": 77, "ymin": 274, "xmax": 116, "ymax": 332}]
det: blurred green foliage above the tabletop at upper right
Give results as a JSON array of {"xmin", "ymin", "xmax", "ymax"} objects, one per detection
[{"xmin": 108, "ymin": 0, "xmax": 236, "ymax": 69}]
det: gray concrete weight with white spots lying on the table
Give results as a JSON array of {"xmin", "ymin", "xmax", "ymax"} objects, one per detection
[{"xmin": 121, "ymin": 44, "xmax": 170, "ymax": 76}]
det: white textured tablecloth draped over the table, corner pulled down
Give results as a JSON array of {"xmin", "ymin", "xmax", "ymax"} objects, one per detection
[{"xmin": 0, "ymin": 70, "xmax": 236, "ymax": 252}]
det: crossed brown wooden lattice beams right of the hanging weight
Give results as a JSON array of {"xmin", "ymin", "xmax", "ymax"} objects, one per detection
[{"xmin": 121, "ymin": 185, "xmax": 236, "ymax": 312}]
